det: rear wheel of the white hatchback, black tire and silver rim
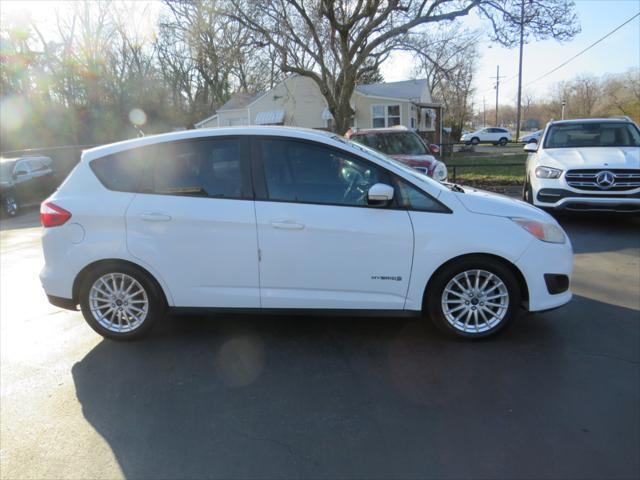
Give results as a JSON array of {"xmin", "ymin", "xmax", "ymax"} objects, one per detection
[{"xmin": 79, "ymin": 264, "xmax": 165, "ymax": 340}]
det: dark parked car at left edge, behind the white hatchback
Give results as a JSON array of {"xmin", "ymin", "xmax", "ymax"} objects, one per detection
[{"xmin": 0, "ymin": 157, "xmax": 56, "ymax": 217}]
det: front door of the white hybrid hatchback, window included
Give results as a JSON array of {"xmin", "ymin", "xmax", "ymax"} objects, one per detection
[{"xmin": 254, "ymin": 138, "xmax": 413, "ymax": 309}]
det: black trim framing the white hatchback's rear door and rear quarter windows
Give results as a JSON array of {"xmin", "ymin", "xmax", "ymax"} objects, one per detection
[{"xmin": 89, "ymin": 134, "xmax": 255, "ymax": 200}]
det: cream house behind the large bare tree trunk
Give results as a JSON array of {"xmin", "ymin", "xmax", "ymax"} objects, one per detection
[{"xmin": 195, "ymin": 75, "xmax": 442, "ymax": 143}]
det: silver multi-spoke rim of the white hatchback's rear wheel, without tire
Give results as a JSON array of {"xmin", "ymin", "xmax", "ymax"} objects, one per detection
[{"xmin": 89, "ymin": 273, "xmax": 149, "ymax": 333}]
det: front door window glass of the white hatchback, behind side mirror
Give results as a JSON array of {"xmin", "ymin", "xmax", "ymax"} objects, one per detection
[{"xmin": 258, "ymin": 139, "xmax": 388, "ymax": 206}]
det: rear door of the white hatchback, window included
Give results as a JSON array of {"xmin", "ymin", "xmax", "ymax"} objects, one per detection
[{"xmin": 126, "ymin": 137, "xmax": 260, "ymax": 308}]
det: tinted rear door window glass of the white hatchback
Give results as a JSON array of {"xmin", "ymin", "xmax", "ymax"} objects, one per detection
[{"xmin": 146, "ymin": 138, "xmax": 243, "ymax": 198}]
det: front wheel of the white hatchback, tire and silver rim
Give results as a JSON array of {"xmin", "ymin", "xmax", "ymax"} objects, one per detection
[{"xmin": 426, "ymin": 257, "xmax": 521, "ymax": 338}]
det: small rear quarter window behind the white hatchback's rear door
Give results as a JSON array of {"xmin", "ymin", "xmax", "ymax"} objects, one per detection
[{"xmin": 91, "ymin": 147, "xmax": 149, "ymax": 192}]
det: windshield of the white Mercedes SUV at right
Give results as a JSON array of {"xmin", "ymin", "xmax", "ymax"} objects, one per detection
[{"xmin": 544, "ymin": 122, "xmax": 640, "ymax": 148}]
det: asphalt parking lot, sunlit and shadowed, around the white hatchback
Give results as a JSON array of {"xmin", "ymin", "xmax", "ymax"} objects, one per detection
[{"xmin": 0, "ymin": 208, "xmax": 640, "ymax": 479}]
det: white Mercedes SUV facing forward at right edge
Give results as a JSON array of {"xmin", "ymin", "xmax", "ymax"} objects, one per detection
[{"xmin": 523, "ymin": 118, "xmax": 640, "ymax": 213}]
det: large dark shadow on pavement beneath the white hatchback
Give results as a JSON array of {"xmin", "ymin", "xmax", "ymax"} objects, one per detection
[{"xmin": 72, "ymin": 297, "xmax": 640, "ymax": 478}]
